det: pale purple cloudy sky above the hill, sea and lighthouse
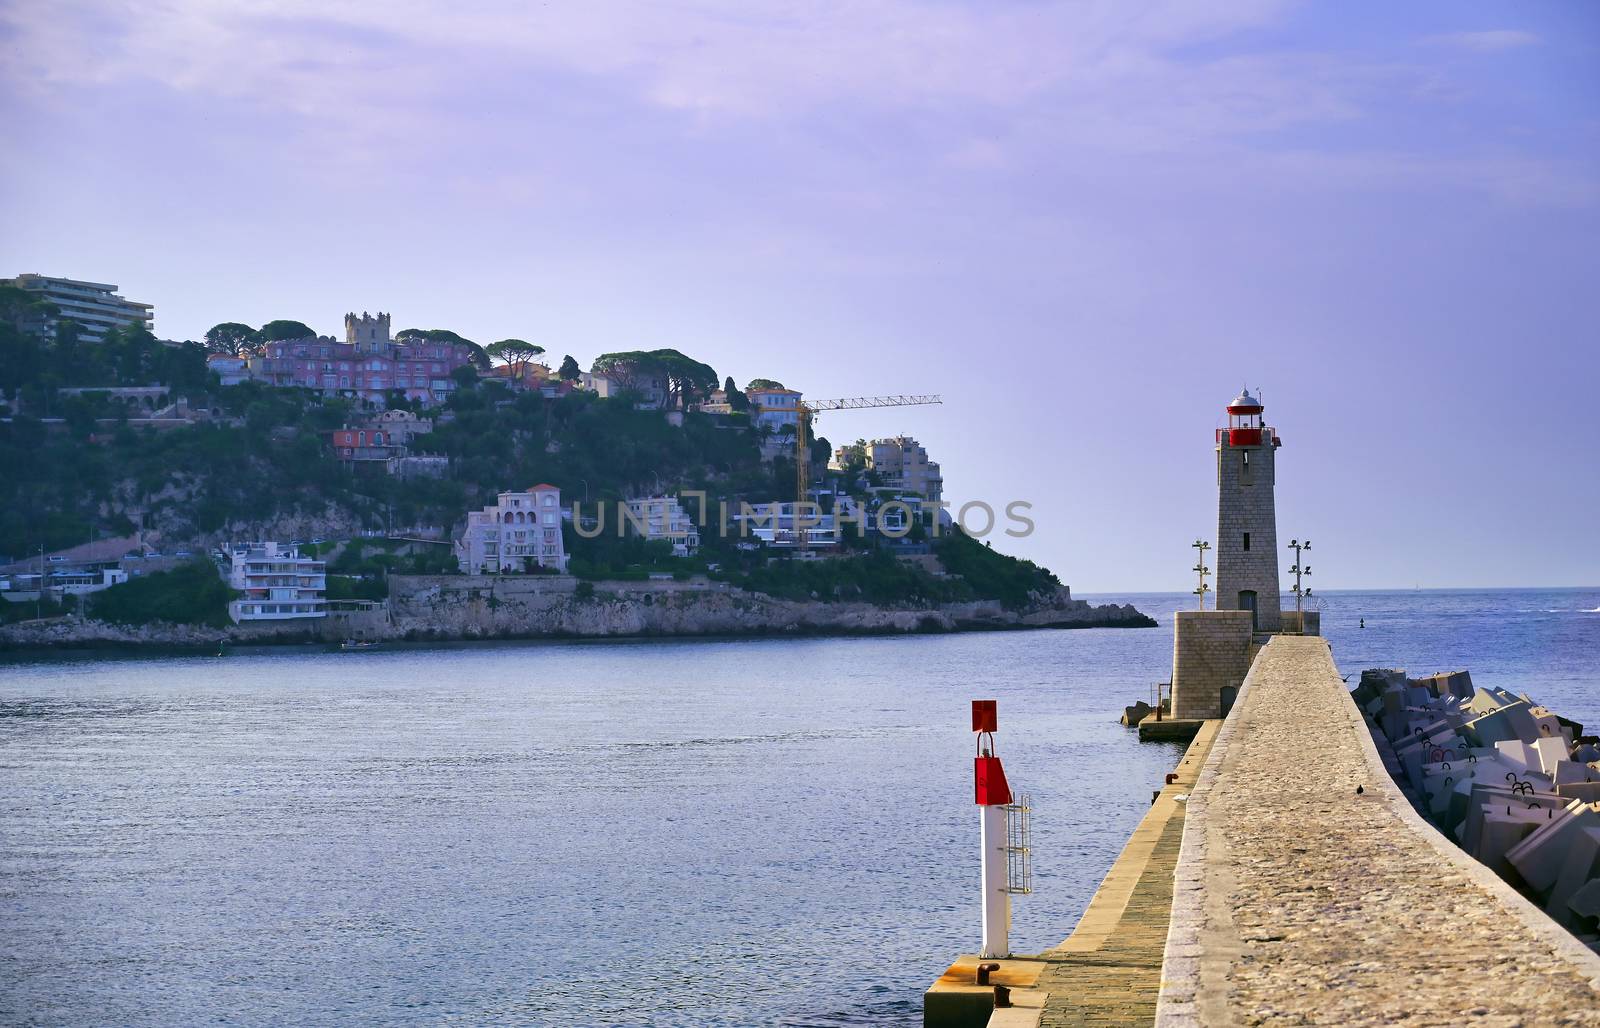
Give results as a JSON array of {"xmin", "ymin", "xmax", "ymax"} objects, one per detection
[{"xmin": 0, "ymin": 0, "xmax": 1600, "ymax": 591}]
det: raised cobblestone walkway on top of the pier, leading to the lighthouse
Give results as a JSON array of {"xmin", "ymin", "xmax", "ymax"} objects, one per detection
[{"xmin": 1164, "ymin": 636, "xmax": 1600, "ymax": 1026}]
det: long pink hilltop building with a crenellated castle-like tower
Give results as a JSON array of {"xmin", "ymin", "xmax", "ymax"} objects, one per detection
[{"xmin": 250, "ymin": 312, "xmax": 474, "ymax": 404}]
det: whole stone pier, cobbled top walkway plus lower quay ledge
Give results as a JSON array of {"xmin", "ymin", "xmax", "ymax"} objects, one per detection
[{"xmin": 923, "ymin": 636, "xmax": 1600, "ymax": 1028}]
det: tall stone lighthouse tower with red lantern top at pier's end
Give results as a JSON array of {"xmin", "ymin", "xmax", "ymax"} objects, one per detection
[{"xmin": 1216, "ymin": 389, "xmax": 1282, "ymax": 632}]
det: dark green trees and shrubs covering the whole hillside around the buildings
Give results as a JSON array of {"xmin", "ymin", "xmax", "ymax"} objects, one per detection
[{"xmin": 0, "ymin": 307, "xmax": 1058, "ymax": 611}]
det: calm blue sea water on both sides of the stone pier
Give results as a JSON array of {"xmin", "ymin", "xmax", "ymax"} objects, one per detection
[{"xmin": 0, "ymin": 589, "xmax": 1600, "ymax": 1025}]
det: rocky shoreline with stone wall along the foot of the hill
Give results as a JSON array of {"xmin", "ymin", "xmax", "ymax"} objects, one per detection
[{"xmin": 0, "ymin": 575, "xmax": 1155, "ymax": 653}]
